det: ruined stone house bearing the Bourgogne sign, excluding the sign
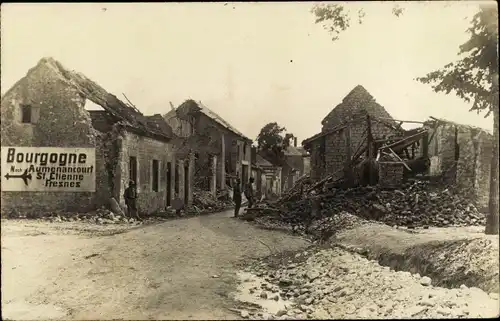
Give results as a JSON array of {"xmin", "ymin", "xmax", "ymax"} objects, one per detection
[{"xmin": 1, "ymin": 58, "xmax": 191, "ymax": 214}]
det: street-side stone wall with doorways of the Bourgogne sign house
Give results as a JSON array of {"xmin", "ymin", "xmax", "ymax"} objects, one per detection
[{"xmin": 119, "ymin": 132, "xmax": 184, "ymax": 214}]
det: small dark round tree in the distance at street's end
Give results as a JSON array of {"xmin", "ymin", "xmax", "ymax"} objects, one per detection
[{"xmin": 257, "ymin": 122, "xmax": 295, "ymax": 165}]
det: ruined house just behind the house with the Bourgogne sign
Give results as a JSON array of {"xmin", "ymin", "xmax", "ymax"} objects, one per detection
[{"xmin": 163, "ymin": 99, "xmax": 252, "ymax": 195}]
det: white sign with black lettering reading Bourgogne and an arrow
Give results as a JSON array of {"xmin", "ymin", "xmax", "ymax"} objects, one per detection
[{"xmin": 2, "ymin": 147, "xmax": 95, "ymax": 192}]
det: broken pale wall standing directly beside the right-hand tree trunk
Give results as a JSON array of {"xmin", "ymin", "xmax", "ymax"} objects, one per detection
[{"xmin": 424, "ymin": 118, "xmax": 494, "ymax": 211}]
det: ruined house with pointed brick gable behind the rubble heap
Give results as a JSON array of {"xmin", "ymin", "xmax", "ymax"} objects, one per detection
[{"xmin": 302, "ymin": 85, "xmax": 404, "ymax": 180}]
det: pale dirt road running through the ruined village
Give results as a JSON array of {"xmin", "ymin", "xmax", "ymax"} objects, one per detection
[{"xmin": 2, "ymin": 211, "xmax": 308, "ymax": 319}]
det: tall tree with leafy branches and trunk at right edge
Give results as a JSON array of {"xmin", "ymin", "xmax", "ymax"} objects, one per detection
[{"xmin": 417, "ymin": 5, "xmax": 499, "ymax": 234}]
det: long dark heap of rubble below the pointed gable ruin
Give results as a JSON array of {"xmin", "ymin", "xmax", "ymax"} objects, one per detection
[{"xmin": 247, "ymin": 180, "xmax": 486, "ymax": 232}]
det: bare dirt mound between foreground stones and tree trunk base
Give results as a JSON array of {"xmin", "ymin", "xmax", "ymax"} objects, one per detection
[{"xmin": 335, "ymin": 224, "xmax": 500, "ymax": 293}]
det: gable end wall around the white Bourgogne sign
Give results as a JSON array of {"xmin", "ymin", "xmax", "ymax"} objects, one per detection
[{"xmin": 1, "ymin": 61, "xmax": 109, "ymax": 215}]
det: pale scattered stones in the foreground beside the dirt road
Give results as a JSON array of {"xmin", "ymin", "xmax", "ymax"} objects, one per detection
[{"xmin": 236, "ymin": 248, "xmax": 498, "ymax": 320}]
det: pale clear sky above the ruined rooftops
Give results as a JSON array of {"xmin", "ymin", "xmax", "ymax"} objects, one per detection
[{"xmin": 1, "ymin": 1, "xmax": 493, "ymax": 141}]
